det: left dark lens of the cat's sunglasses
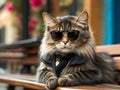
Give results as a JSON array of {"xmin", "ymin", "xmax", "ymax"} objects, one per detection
[{"xmin": 51, "ymin": 30, "xmax": 63, "ymax": 41}]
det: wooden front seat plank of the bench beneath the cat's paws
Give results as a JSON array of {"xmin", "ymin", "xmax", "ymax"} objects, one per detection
[{"xmin": 0, "ymin": 75, "xmax": 120, "ymax": 90}]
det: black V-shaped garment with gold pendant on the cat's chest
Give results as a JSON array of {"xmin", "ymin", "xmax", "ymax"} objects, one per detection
[{"xmin": 42, "ymin": 54, "xmax": 87, "ymax": 77}]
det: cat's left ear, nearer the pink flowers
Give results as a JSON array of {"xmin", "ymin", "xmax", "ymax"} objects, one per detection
[{"xmin": 42, "ymin": 12, "xmax": 57, "ymax": 26}]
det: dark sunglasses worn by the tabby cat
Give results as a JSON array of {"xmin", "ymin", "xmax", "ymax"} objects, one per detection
[{"xmin": 50, "ymin": 30, "xmax": 80, "ymax": 41}]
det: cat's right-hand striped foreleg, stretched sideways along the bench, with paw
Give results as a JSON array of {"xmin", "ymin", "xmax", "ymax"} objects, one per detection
[{"xmin": 58, "ymin": 70, "xmax": 102, "ymax": 86}]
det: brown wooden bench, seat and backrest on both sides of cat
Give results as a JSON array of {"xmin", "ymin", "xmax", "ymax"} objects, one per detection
[{"xmin": 0, "ymin": 39, "xmax": 120, "ymax": 90}]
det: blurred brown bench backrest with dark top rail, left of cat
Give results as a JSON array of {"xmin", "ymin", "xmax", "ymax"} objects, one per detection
[{"xmin": 0, "ymin": 38, "xmax": 41, "ymax": 73}]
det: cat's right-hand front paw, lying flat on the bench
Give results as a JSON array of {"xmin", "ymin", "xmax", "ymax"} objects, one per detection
[{"xmin": 58, "ymin": 75, "xmax": 74, "ymax": 86}]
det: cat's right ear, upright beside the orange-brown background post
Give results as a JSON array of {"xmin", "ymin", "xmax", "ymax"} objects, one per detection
[{"xmin": 77, "ymin": 10, "xmax": 89, "ymax": 22}]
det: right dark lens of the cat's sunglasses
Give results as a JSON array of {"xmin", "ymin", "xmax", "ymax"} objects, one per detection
[{"xmin": 68, "ymin": 30, "xmax": 79, "ymax": 41}]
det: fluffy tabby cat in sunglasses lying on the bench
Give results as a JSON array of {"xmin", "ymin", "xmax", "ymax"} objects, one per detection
[{"xmin": 36, "ymin": 10, "xmax": 115, "ymax": 90}]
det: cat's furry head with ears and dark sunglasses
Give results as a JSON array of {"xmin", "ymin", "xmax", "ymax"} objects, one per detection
[{"xmin": 40, "ymin": 10, "xmax": 94, "ymax": 55}]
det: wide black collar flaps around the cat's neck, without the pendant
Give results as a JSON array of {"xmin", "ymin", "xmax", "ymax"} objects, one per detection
[{"xmin": 41, "ymin": 53, "xmax": 86, "ymax": 66}]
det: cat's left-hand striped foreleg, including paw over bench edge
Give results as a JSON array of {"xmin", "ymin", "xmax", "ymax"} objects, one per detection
[{"xmin": 36, "ymin": 63, "xmax": 58, "ymax": 90}]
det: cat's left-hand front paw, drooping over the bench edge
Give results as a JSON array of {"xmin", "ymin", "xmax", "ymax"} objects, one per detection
[{"xmin": 46, "ymin": 77, "xmax": 58, "ymax": 90}]
